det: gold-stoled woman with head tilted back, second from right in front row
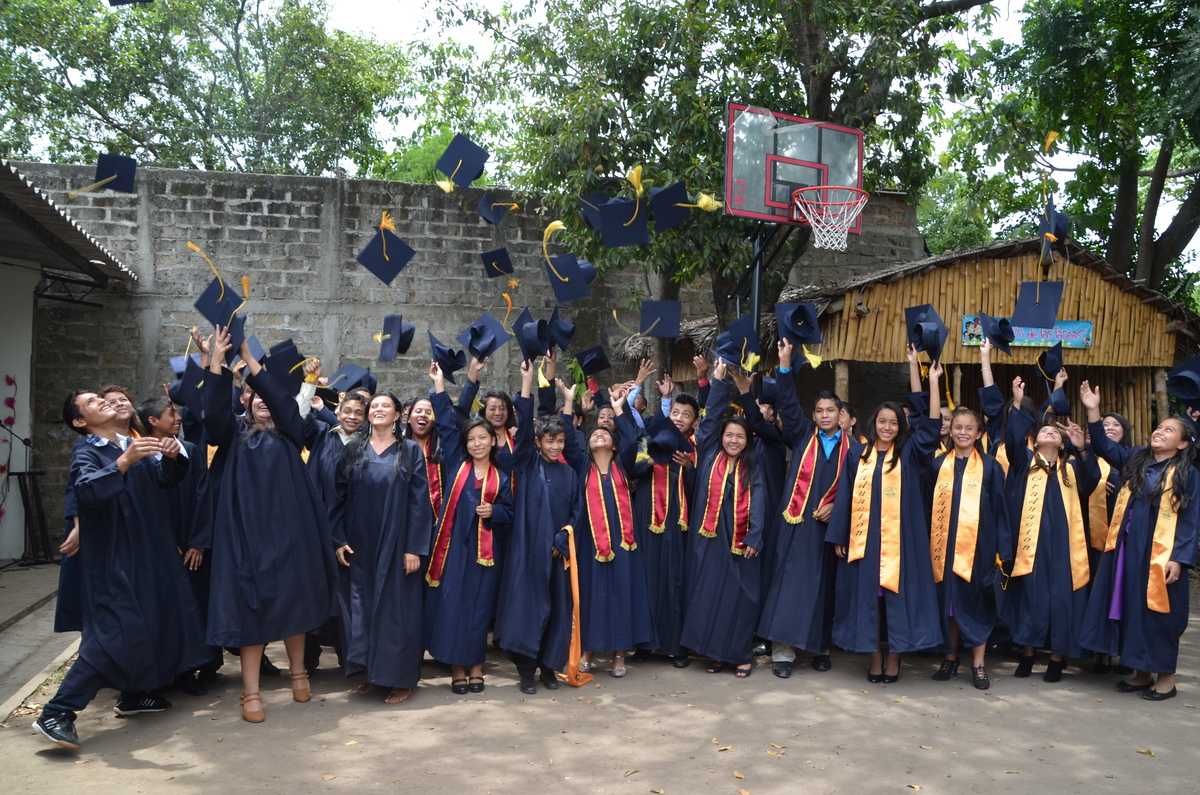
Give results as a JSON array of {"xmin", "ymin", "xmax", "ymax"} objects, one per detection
[{"xmin": 1001, "ymin": 376, "xmax": 1100, "ymax": 682}]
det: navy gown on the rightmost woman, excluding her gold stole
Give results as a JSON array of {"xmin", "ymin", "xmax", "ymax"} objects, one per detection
[{"xmin": 1081, "ymin": 423, "xmax": 1200, "ymax": 674}]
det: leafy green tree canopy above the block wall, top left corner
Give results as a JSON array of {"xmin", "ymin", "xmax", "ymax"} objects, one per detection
[{"xmin": 0, "ymin": 0, "xmax": 408, "ymax": 174}]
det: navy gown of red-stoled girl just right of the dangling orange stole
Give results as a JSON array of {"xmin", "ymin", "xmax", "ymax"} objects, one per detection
[{"xmin": 562, "ymin": 407, "xmax": 654, "ymax": 652}]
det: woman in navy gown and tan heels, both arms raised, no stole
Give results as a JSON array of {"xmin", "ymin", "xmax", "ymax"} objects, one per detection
[{"xmin": 204, "ymin": 328, "xmax": 336, "ymax": 723}]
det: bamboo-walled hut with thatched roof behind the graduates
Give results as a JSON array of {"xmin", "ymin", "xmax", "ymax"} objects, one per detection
[{"xmin": 617, "ymin": 238, "xmax": 1200, "ymax": 443}]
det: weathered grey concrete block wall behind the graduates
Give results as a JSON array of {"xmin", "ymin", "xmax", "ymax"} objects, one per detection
[{"xmin": 18, "ymin": 163, "xmax": 919, "ymax": 528}]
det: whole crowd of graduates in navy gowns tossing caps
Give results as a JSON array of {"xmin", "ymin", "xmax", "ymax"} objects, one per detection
[{"xmin": 28, "ymin": 317, "xmax": 1200, "ymax": 748}]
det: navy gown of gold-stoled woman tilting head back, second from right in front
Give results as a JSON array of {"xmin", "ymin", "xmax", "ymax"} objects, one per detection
[{"xmin": 1001, "ymin": 408, "xmax": 1100, "ymax": 657}]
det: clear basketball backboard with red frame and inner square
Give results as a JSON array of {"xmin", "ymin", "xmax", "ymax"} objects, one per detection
[{"xmin": 725, "ymin": 102, "xmax": 863, "ymax": 234}]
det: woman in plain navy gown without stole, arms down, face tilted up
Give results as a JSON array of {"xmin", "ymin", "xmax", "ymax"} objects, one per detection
[{"xmin": 329, "ymin": 393, "xmax": 433, "ymax": 704}]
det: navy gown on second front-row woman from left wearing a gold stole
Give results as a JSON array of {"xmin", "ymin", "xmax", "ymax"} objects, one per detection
[{"xmin": 925, "ymin": 452, "xmax": 1013, "ymax": 652}]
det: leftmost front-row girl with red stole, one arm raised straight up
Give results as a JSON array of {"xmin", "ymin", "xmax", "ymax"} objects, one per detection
[{"xmin": 425, "ymin": 364, "xmax": 512, "ymax": 695}]
